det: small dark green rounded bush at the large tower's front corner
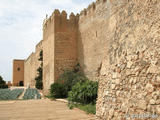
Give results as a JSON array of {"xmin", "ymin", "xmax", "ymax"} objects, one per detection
[{"xmin": 50, "ymin": 83, "xmax": 67, "ymax": 98}]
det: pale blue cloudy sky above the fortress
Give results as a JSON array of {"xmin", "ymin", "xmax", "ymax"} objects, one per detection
[{"xmin": 0, "ymin": 0, "xmax": 95, "ymax": 81}]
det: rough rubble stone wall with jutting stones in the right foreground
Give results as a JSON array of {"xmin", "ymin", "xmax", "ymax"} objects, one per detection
[{"xmin": 95, "ymin": 0, "xmax": 160, "ymax": 120}]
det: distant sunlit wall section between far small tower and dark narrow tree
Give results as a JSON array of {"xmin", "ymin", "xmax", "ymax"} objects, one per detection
[{"xmin": 24, "ymin": 53, "xmax": 37, "ymax": 87}]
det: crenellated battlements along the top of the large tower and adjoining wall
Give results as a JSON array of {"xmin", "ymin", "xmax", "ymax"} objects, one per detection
[{"xmin": 43, "ymin": 0, "xmax": 121, "ymax": 30}]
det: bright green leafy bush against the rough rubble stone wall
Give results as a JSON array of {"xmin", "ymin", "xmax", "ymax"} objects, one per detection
[{"xmin": 68, "ymin": 80, "xmax": 98, "ymax": 104}]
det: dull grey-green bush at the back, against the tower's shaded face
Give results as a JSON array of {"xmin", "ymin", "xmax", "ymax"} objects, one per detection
[{"xmin": 58, "ymin": 70, "xmax": 87, "ymax": 91}]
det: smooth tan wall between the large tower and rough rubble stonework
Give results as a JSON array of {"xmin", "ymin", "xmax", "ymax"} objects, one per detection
[{"xmin": 78, "ymin": 0, "xmax": 115, "ymax": 80}]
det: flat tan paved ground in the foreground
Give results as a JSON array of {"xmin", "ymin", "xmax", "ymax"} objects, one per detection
[{"xmin": 0, "ymin": 99, "xmax": 95, "ymax": 120}]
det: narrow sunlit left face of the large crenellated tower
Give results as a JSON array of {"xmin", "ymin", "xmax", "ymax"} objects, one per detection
[{"xmin": 43, "ymin": 10, "xmax": 56, "ymax": 93}]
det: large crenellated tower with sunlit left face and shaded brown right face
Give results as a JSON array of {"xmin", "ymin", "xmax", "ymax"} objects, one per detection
[{"xmin": 43, "ymin": 10, "xmax": 78, "ymax": 93}]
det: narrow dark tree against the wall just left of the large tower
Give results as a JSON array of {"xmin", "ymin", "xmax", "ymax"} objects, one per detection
[{"xmin": 35, "ymin": 50, "xmax": 43, "ymax": 90}]
